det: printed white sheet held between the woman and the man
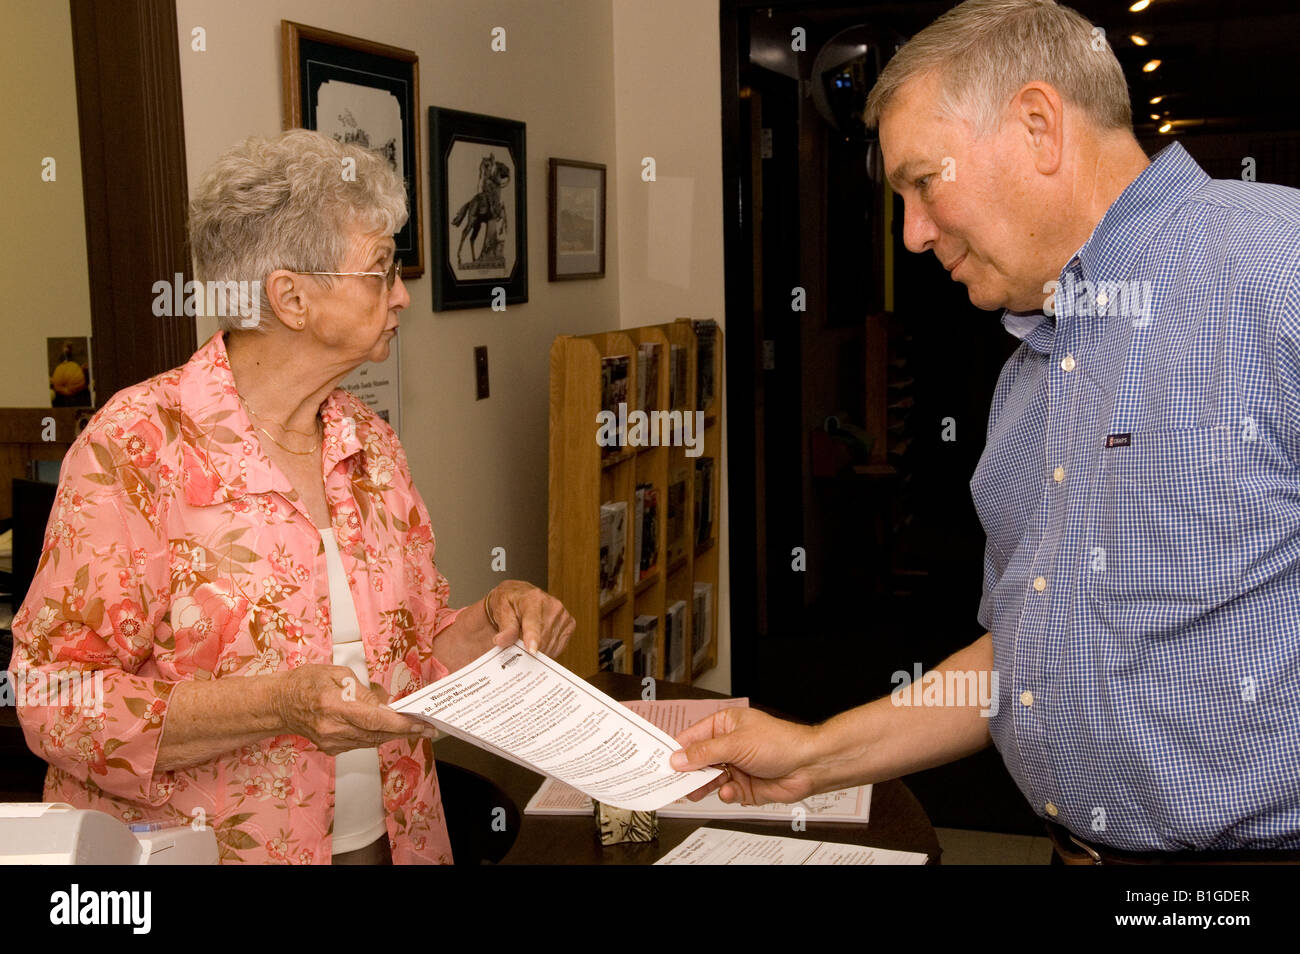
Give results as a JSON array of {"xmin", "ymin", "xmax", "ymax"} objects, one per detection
[{"xmin": 393, "ymin": 642, "xmax": 722, "ymax": 811}]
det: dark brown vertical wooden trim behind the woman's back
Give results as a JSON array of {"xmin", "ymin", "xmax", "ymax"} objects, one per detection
[{"xmin": 70, "ymin": 0, "xmax": 196, "ymax": 404}]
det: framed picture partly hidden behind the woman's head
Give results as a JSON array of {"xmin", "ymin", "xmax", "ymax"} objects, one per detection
[{"xmin": 280, "ymin": 19, "xmax": 424, "ymax": 281}]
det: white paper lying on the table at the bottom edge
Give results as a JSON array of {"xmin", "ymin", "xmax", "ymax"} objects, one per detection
[{"xmin": 655, "ymin": 828, "xmax": 928, "ymax": 864}]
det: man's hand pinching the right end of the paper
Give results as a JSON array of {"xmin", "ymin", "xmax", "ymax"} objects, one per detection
[{"xmin": 671, "ymin": 708, "xmax": 816, "ymax": 805}]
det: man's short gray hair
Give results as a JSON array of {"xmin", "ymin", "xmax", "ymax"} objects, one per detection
[{"xmin": 862, "ymin": 0, "xmax": 1132, "ymax": 136}]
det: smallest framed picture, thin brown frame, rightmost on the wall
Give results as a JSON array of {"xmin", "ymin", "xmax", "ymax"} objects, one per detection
[{"xmin": 546, "ymin": 159, "xmax": 605, "ymax": 282}]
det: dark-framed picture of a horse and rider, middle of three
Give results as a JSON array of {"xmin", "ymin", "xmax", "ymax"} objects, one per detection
[{"xmin": 429, "ymin": 107, "xmax": 528, "ymax": 312}]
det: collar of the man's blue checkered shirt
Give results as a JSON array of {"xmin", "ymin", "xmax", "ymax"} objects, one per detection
[{"xmin": 1002, "ymin": 143, "xmax": 1210, "ymax": 355}]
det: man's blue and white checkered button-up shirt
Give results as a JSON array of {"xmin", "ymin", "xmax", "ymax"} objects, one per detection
[{"xmin": 971, "ymin": 143, "xmax": 1300, "ymax": 851}]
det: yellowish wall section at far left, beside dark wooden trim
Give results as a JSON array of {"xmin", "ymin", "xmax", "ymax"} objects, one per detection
[{"xmin": 0, "ymin": 0, "xmax": 94, "ymax": 407}]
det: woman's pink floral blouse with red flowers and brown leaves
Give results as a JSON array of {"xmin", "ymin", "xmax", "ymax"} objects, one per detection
[{"xmin": 10, "ymin": 334, "xmax": 460, "ymax": 864}]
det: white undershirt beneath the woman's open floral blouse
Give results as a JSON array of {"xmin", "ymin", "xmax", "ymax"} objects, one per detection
[{"xmin": 320, "ymin": 529, "xmax": 387, "ymax": 855}]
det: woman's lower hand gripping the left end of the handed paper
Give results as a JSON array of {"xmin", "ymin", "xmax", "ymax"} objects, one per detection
[{"xmin": 277, "ymin": 664, "xmax": 437, "ymax": 755}]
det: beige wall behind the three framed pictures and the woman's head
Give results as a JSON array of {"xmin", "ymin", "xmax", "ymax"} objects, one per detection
[{"xmin": 177, "ymin": 0, "xmax": 618, "ymax": 621}]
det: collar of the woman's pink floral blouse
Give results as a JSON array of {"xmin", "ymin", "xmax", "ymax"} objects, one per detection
[{"xmin": 179, "ymin": 331, "xmax": 364, "ymax": 507}]
